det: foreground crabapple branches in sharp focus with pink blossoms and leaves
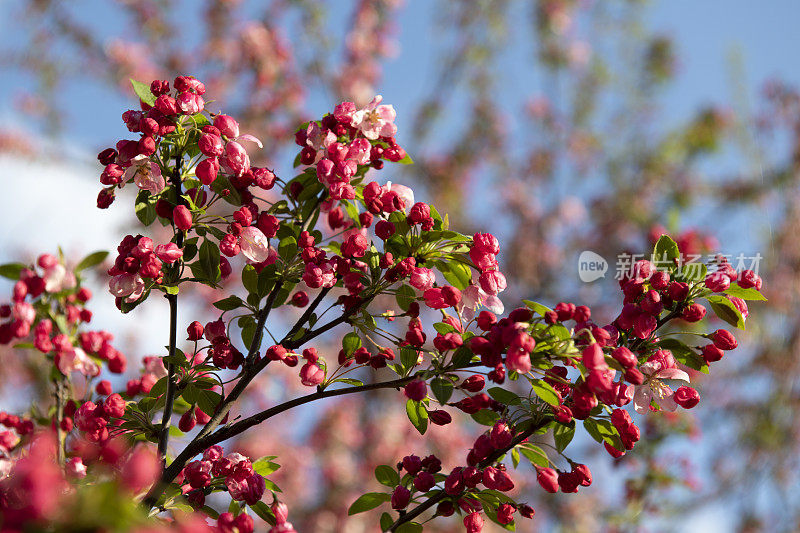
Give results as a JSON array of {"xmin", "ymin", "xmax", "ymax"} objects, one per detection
[{"xmin": 0, "ymin": 76, "xmax": 764, "ymax": 533}]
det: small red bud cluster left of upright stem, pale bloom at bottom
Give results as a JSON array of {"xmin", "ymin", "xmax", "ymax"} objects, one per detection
[{"xmin": 108, "ymin": 235, "xmax": 183, "ymax": 306}]
